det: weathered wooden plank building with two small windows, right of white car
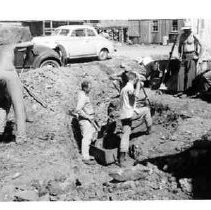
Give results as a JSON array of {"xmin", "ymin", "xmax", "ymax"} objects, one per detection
[{"xmin": 128, "ymin": 19, "xmax": 184, "ymax": 44}]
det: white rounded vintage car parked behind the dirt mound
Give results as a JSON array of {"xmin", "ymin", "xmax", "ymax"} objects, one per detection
[{"xmin": 32, "ymin": 25, "xmax": 115, "ymax": 61}]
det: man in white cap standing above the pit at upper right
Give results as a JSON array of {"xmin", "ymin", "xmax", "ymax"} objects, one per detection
[{"xmin": 177, "ymin": 22, "xmax": 202, "ymax": 93}]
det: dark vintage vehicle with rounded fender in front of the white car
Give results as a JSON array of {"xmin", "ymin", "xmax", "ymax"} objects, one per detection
[{"xmin": 14, "ymin": 42, "xmax": 62, "ymax": 69}]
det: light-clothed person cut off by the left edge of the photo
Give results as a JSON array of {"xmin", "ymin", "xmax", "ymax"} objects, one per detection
[{"xmin": 0, "ymin": 46, "xmax": 27, "ymax": 143}]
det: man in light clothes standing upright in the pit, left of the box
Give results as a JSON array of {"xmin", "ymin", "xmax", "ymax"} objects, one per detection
[{"xmin": 76, "ymin": 81, "xmax": 96, "ymax": 164}]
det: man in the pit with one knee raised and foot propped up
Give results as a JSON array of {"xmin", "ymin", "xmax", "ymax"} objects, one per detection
[{"xmin": 119, "ymin": 72, "xmax": 152, "ymax": 166}]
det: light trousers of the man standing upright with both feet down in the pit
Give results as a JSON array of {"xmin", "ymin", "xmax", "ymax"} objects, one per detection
[{"xmin": 79, "ymin": 120, "xmax": 96, "ymax": 160}]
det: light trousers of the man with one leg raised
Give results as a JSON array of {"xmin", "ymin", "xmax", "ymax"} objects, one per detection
[{"xmin": 120, "ymin": 107, "xmax": 152, "ymax": 152}]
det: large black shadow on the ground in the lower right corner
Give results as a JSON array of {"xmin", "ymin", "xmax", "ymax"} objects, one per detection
[{"xmin": 139, "ymin": 131, "xmax": 211, "ymax": 199}]
